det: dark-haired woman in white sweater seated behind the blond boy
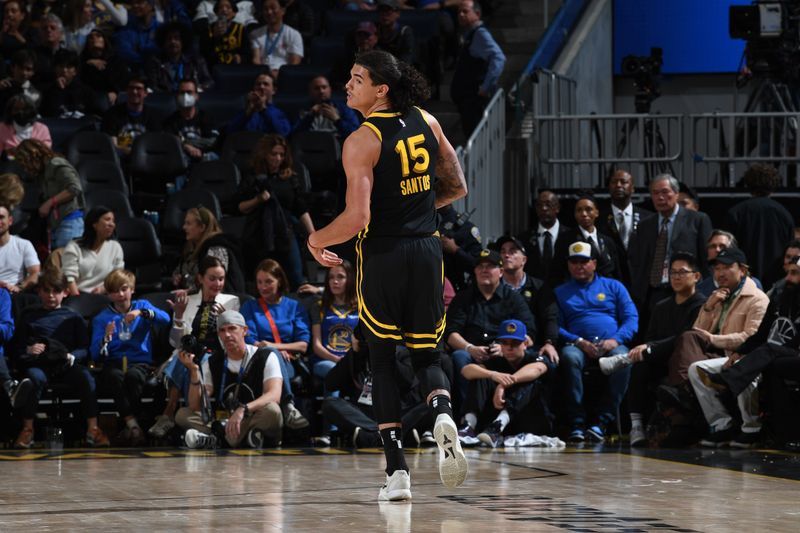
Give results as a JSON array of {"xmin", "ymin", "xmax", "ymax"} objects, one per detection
[{"xmin": 61, "ymin": 206, "xmax": 125, "ymax": 296}]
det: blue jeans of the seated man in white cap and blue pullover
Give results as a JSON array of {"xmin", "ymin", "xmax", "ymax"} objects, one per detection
[{"xmin": 559, "ymin": 345, "xmax": 631, "ymax": 428}]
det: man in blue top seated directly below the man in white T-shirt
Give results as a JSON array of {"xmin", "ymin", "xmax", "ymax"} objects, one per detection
[{"xmin": 228, "ymin": 72, "xmax": 292, "ymax": 137}]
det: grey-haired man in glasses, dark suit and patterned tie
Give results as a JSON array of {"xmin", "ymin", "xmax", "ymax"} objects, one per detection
[{"xmin": 628, "ymin": 174, "xmax": 711, "ymax": 316}]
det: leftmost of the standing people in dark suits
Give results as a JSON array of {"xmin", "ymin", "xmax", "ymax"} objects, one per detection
[{"xmin": 520, "ymin": 189, "xmax": 570, "ymax": 287}]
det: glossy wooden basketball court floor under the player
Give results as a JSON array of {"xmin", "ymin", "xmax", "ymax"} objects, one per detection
[{"xmin": 0, "ymin": 448, "xmax": 800, "ymax": 533}]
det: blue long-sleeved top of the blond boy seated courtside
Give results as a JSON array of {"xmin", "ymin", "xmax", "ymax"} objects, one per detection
[{"xmin": 89, "ymin": 300, "xmax": 170, "ymax": 364}]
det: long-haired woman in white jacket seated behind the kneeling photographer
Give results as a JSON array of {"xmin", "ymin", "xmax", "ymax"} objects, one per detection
[{"xmin": 148, "ymin": 256, "xmax": 239, "ymax": 438}]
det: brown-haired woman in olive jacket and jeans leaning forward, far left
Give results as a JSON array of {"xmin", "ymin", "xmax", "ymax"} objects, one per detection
[{"xmin": 15, "ymin": 139, "xmax": 84, "ymax": 250}]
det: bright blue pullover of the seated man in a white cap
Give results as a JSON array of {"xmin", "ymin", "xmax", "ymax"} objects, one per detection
[{"xmin": 554, "ymin": 274, "xmax": 639, "ymax": 344}]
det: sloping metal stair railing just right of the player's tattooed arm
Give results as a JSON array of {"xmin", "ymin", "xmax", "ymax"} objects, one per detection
[{"xmin": 454, "ymin": 89, "xmax": 506, "ymax": 245}]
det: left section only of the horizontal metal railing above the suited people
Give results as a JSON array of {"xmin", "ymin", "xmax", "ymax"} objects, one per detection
[{"xmin": 533, "ymin": 114, "xmax": 684, "ymax": 188}]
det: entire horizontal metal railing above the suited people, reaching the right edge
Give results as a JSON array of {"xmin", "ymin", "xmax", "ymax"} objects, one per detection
[{"xmin": 536, "ymin": 113, "xmax": 800, "ymax": 189}]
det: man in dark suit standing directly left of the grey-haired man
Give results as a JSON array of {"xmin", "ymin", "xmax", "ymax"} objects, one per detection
[{"xmin": 597, "ymin": 169, "xmax": 654, "ymax": 287}]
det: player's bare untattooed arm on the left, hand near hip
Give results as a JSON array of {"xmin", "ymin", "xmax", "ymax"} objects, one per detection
[{"xmin": 308, "ymin": 128, "xmax": 381, "ymax": 266}]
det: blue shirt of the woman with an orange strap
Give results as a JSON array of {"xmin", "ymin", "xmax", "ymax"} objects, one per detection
[{"xmin": 239, "ymin": 296, "xmax": 311, "ymax": 344}]
